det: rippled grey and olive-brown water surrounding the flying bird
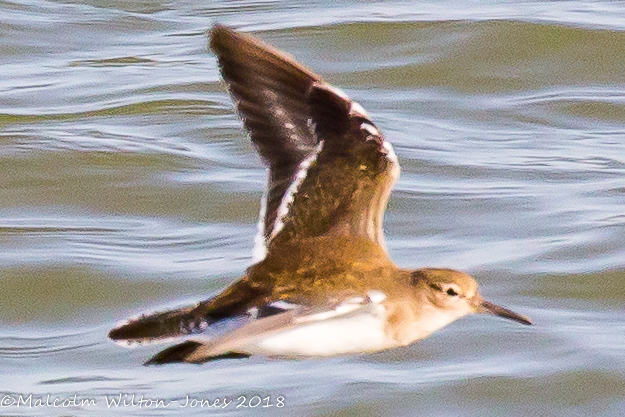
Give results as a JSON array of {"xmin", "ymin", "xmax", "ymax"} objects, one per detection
[{"xmin": 0, "ymin": 0, "xmax": 625, "ymax": 416}]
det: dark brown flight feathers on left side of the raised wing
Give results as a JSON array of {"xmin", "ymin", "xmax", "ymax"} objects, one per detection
[{"xmin": 210, "ymin": 25, "xmax": 321, "ymax": 247}]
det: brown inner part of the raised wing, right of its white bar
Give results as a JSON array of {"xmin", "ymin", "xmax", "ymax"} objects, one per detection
[{"xmin": 276, "ymin": 83, "xmax": 399, "ymax": 247}]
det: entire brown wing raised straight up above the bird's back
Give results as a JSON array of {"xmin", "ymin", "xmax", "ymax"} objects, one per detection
[{"xmin": 211, "ymin": 25, "xmax": 399, "ymax": 260}]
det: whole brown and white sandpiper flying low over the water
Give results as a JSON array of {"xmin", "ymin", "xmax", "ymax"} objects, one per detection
[{"xmin": 109, "ymin": 25, "xmax": 531, "ymax": 364}]
